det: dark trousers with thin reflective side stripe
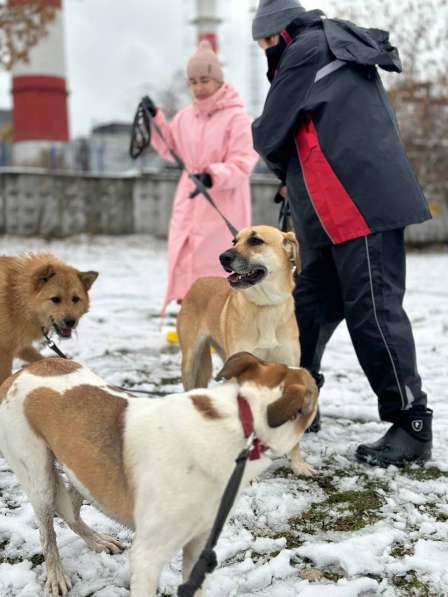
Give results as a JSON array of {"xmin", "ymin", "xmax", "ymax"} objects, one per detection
[{"xmin": 294, "ymin": 229, "xmax": 426, "ymax": 421}]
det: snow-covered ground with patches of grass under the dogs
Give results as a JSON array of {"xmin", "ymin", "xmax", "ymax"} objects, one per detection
[{"xmin": 0, "ymin": 236, "xmax": 448, "ymax": 597}]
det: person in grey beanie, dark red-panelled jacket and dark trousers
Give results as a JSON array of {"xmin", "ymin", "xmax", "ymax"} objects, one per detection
[{"xmin": 252, "ymin": 0, "xmax": 432, "ymax": 466}]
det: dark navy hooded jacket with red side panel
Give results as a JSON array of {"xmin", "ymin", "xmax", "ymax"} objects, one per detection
[{"xmin": 253, "ymin": 10, "xmax": 431, "ymax": 248}]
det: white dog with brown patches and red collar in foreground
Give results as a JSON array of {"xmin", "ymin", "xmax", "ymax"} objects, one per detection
[{"xmin": 0, "ymin": 353, "xmax": 317, "ymax": 597}]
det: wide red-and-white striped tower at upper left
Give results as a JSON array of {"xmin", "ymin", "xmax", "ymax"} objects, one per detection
[{"xmin": 9, "ymin": 0, "xmax": 69, "ymax": 165}]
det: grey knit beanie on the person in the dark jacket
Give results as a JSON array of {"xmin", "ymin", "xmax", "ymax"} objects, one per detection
[{"xmin": 252, "ymin": 0, "xmax": 305, "ymax": 40}]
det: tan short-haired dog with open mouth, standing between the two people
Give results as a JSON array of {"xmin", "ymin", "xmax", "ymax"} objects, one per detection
[{"xmin": 177, "ymin": 226, "xmax": 314, "ymax": 476}]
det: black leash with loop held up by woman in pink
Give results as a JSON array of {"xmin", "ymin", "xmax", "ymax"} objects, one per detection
[{"xmin": 129, "ymin": 95, "xmax": 238, "ymax": 238}]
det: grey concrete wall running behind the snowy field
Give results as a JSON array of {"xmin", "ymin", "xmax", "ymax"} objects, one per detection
[{"xmin": 0, "ymin": 169, "xmax": 448, "ymax": 245}]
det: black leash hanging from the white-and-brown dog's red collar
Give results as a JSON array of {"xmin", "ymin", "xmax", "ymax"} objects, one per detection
[{"xmin": 177, "ymin": 433, "xmax": 255, "ymax": 597}]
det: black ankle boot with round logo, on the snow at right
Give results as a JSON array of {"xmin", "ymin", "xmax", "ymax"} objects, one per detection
[{"xmin": 355, "ymin": 408, "xmax": 432, "ymax": 466}]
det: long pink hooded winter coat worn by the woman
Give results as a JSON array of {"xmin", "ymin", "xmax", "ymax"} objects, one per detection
[{"xmin": 152, "ymin": 84, "xmax": 258, "ymax": 312}]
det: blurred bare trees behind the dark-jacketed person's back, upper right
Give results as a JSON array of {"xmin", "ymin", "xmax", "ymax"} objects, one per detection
[{"xmin": 327, "ymin": 0, "xmax": 448, "ymax": 202}]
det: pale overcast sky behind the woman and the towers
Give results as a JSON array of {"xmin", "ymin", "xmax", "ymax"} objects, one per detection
[{"xmin": 0, "ymin": 0, "xmax": 336, "ymax": 137}]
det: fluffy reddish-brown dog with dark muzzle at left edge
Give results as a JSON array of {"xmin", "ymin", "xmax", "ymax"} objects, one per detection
[{"xmin": 0, "ymin": 254, "xmax": 98, "ymax": 383}]
